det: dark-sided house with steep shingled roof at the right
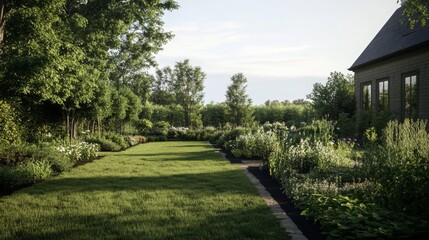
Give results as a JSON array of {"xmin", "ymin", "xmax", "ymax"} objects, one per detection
[{"xmin": 350, "ymin": 2, "xmax": 429, "ymax": 119}]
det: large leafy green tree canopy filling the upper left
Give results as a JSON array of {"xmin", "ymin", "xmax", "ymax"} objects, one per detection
[{"xmin": 0, "ymin": 0, "xmax": 178, "ymax": 139}]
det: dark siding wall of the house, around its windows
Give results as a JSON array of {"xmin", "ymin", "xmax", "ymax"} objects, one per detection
[{"xmin": 355, "ymin": 46, "xmax": 429, "ymax": 119}]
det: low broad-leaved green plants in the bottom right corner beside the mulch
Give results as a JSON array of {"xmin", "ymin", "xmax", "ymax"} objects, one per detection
[{"xmin": 301, "ymin": 194, "xmax": 427, "ymax": 239}]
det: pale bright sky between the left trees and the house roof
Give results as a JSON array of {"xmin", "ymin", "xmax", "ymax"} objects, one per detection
[{"xmin": 156, "ymin": 0, "xmax": 400, "ymax": 105}]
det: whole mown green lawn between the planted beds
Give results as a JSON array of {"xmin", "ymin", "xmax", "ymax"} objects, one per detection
[{"xmin": 0, "ymin": 142, "xmax": 288, "ymax": 239}]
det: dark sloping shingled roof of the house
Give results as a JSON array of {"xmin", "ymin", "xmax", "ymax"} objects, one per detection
[{"xmin": 350, "ymin": 6, "xmax": 429, "ymax": 71}]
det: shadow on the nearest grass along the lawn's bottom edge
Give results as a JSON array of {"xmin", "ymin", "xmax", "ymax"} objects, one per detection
[{"xmin": 4, "ymin": 206, "xmax": 288, "ymax": 240}]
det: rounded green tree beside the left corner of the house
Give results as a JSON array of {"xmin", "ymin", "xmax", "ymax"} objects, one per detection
[{"xmin": 307, "ymin": 72, "xmax": 355, "ymax": 120}]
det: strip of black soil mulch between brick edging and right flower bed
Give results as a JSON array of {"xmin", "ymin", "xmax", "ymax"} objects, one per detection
[{"xmin": 222, "ymin": 148, "xmax": 326, "ymax": 240}]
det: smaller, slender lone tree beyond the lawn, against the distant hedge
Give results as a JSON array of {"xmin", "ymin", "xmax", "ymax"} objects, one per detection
[{"xmin": 226, "ymin": 73, "xmax": 253, "ymax": 126}]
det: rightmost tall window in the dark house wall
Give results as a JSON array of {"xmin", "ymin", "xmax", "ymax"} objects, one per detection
[{"xmin": 403, "ymin": 73, "xmax": 417, "ymax": 119}]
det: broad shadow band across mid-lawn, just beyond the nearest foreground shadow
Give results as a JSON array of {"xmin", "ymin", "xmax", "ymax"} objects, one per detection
[{"xmin": 21, "ymin": 169, "xmax": 251, "ymax": 197}]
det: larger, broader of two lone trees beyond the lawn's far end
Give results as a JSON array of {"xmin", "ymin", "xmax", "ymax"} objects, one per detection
[{"xmin": 171, "ymin": 59, "xmax": 206, "ymax": 127}]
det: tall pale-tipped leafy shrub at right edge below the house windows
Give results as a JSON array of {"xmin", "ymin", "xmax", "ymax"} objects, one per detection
[{"xmin": 363, "ymin": 120, "xmax": 429, "ymax": 220}]
